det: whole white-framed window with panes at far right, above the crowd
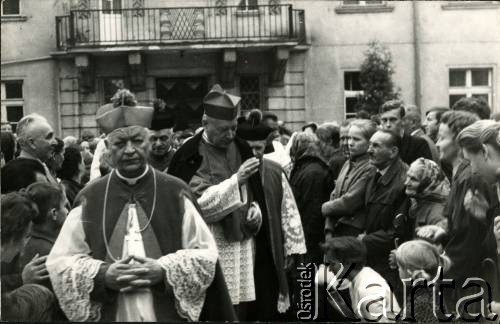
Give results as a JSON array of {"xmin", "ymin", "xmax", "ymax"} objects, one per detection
[{"xmin": 449, "ymin": 68, "xmax": 493, "ymax": 107}]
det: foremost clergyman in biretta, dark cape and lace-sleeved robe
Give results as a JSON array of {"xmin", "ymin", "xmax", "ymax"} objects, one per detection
[{"xmin": 47, "ymin": 90, "xmax": 235, "ymax": 322}]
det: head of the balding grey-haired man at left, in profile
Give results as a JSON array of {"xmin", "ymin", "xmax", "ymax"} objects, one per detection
[{"xmin": 17, "ymin": 113, "xmax": 57, "ymax": 183}]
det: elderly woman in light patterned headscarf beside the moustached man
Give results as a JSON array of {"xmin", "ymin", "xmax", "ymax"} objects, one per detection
[{"xmin": 405, "ymin": 158, "xmax": 450, "ymax": 234}]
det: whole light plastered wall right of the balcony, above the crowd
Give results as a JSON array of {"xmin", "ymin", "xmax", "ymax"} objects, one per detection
[{"xmin": 287, "ymin": 0, "xmax": 500, "ymax": 122}]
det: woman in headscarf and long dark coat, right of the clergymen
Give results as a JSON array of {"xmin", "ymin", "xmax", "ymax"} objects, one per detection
[{"xmin": 290, "ymin": 132, "xmax": 331, "ymax": 264}]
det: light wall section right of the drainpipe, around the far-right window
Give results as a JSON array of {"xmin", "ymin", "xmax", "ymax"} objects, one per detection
[{"xmin": 419, "ymin": 1, "xmax": 500, "ymax": 112}]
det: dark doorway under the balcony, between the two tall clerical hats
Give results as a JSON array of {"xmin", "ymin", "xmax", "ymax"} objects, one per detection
[{"xmin": 156, "ymin": 77, "xmax": 208, "ymax": 131}]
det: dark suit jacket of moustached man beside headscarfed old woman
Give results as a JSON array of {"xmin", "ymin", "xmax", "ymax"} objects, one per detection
[{"xmin": 363, "ymin": 159, "xmax": 408, "ymax": 271}]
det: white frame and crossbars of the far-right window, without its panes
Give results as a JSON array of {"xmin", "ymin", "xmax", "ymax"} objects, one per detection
[{"xmin": 448, "ymin": 65, "xmax": 495, "ymax": 111}]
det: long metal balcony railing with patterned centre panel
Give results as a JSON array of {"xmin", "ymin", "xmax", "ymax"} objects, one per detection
[{"xmin": 56, "ymin": 5, "xmax": 305, "ymax": 50}]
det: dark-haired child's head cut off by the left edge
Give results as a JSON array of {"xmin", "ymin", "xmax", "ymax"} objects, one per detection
[{"xmin": 1, "ymin": 192, "xmax": 38, "ymax": 262}]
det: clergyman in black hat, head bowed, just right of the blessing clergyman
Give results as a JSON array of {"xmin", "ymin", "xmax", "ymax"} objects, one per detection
[{"xmin": 236, "ymin": 110, "xmax": 306, "ymax": 320}]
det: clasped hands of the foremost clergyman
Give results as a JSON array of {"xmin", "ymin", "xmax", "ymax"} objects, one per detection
[{"xmin": 105, "ymin": 255, "xmax": 165, "ymax": 292}]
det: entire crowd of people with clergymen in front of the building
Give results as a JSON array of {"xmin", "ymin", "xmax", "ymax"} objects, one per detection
[{"xmin": 1, "ymin": 85, "xmax": 500, "ymax": 322}]
